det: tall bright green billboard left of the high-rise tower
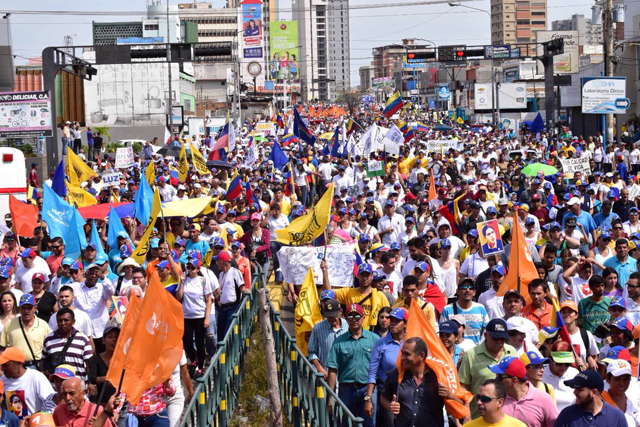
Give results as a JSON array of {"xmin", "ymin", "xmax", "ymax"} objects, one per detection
[{"xmin": 269, "ymin": 21, "xmax": 300, "ymax": 80}]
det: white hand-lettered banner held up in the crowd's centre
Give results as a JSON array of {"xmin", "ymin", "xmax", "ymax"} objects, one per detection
[{"xmin": 278, "ymin": 243, "xmax": 356, "ymax": 288}]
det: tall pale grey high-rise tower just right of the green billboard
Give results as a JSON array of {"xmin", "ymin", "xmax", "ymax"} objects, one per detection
[{"xmin": 292, "ymin": 0, "xmax": 351, "ymax": 100}]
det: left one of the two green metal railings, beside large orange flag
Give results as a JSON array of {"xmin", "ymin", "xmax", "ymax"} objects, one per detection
[{"xmin": 178, "ymin": 267, "xmax": 263, "ymax": 427}]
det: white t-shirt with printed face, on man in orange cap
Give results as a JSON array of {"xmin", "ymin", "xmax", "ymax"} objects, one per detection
[{"xmin": 0, "ymin": 369, "xmax": 55, "ymax": 419}]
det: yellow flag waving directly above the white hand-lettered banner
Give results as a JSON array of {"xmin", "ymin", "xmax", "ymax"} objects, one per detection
[{"xmin": 276, "ymin": 183, "xmax": 336, "ymax": 246}]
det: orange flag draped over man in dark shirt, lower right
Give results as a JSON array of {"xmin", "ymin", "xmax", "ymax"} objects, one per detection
[{"xmin": 396, "ymin": 299, "xmax": 473, "ymax": 419}]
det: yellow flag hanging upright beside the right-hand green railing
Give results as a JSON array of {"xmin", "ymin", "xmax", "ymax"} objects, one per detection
[{"xmin": 294, "ymin": 270, "xmax": 322, "ymax": 356}]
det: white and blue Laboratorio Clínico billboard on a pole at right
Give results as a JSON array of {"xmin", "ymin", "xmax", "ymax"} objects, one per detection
[{"xmin": 582, "ymin": 77, "xmax": 630, "ymax": 114}]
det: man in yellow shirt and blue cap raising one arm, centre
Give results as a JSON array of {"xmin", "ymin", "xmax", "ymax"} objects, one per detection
[{"xmin": 320, "ymin": 260, "xmax": 389, "ymax": 330}]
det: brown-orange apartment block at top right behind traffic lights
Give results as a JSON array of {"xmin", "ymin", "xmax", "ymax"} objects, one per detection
[{"xmin": 491, "ymin": 0, "xmax": 547, "ymax": 50}]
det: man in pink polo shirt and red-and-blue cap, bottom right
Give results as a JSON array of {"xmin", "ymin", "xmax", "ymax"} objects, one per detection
[{"xmin": 489, "ymin": 356, "xmax": 558, "ymax": 427}]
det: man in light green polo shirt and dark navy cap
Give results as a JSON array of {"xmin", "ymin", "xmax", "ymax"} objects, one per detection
[{"xmin": 459, "ymin": 319, "xmax": 517, "ymax": 419}]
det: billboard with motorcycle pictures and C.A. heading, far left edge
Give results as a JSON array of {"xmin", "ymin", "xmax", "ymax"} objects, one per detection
[{"xmin": 0, "ymin": 91, "xmax": 53, "ymax": 137}]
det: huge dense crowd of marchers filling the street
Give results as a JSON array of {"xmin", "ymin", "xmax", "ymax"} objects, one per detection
[{"xmin": 0, "ymin": 105, "xmax": 640, "ymax": 427}]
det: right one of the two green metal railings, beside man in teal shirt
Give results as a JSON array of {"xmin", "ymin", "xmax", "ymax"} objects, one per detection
[{"xmin": 270, "ymin": 290, "xmax": 364, "ymax": 427}]
